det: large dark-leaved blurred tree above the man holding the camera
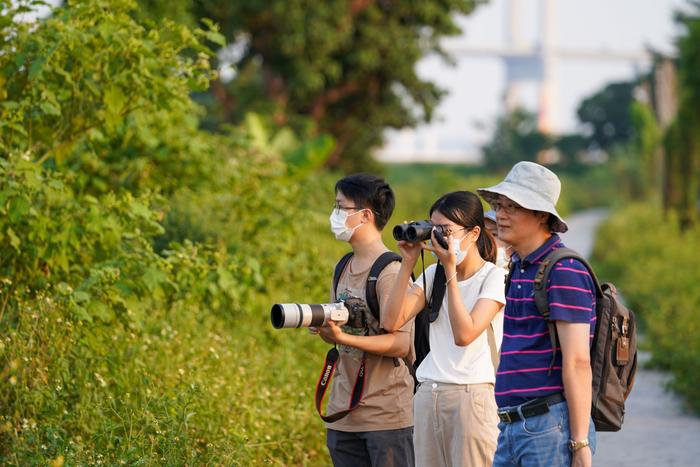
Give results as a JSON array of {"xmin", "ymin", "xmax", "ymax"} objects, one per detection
[{"xmin": 141, "ymin": 0, "xmax": 478, "ymax": 170}]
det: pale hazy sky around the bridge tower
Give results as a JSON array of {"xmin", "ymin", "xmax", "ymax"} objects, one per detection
[{"xmin": 378, "ymin": 0, "xmax": 687, "ymax": 163}]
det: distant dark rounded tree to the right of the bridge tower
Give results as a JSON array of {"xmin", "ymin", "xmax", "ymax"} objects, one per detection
[{"xmin": 577, "ymin": 82, "xmax": 635, "ymax": 150}]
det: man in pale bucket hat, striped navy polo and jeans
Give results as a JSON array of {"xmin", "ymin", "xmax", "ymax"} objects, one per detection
[{"xmin": 477, "ymin": 162, "xmax": 596, "ymax": 467}]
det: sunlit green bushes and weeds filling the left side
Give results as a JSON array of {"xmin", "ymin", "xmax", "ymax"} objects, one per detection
[{"xmin": 0, "ymin": 0, "xmax": 342, "ymax": 465}]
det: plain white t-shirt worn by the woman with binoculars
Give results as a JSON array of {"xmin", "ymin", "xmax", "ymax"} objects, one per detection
[{"xmin": 415, "ymin": 262, "xmax": 507, "ymax": 384}]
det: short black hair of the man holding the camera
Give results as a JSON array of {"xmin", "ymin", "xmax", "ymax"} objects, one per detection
[{"xmin": 335, "ymin": 173, "xmax": 396, "ymax": 230}]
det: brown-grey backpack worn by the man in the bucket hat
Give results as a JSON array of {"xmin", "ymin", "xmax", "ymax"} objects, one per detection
[{"xmin": 506, "ymin": 248, "xmax": 637, "ymax": 431}]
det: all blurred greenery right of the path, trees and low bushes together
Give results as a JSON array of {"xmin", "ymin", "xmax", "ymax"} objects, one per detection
[{"xmin": 594, "ymin": 1, "xmax": 700, "ymax": 413}]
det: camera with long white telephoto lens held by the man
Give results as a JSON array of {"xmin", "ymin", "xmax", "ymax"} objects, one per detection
[{"xmin": 270, "ymin": 298, "xmax": 377, "ymax": 329}]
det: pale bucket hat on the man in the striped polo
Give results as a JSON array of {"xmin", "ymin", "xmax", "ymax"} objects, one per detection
[{"xmin": 476, "ymin": 161, "xmax": 569, "ymax": 233}]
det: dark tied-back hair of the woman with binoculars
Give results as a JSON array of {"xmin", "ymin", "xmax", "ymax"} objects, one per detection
[{"xmin": 430, "ymin": 191, "xmax": 498, "ymax": 263}]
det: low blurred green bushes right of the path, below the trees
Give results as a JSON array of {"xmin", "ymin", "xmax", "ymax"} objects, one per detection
[{"xmin": 594, "ymin": 204, "xmax": 700, "ymax": 413}]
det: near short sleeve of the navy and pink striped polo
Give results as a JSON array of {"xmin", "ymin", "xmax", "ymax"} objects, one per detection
[{"xmin": 547, "ymin": 258, "xmax": 595, "ymax": 323}]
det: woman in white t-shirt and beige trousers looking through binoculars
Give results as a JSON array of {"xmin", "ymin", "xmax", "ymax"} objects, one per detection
[{"xmin": 383, "ymin": 191, "xmax": 506, "ymax": 466}]
